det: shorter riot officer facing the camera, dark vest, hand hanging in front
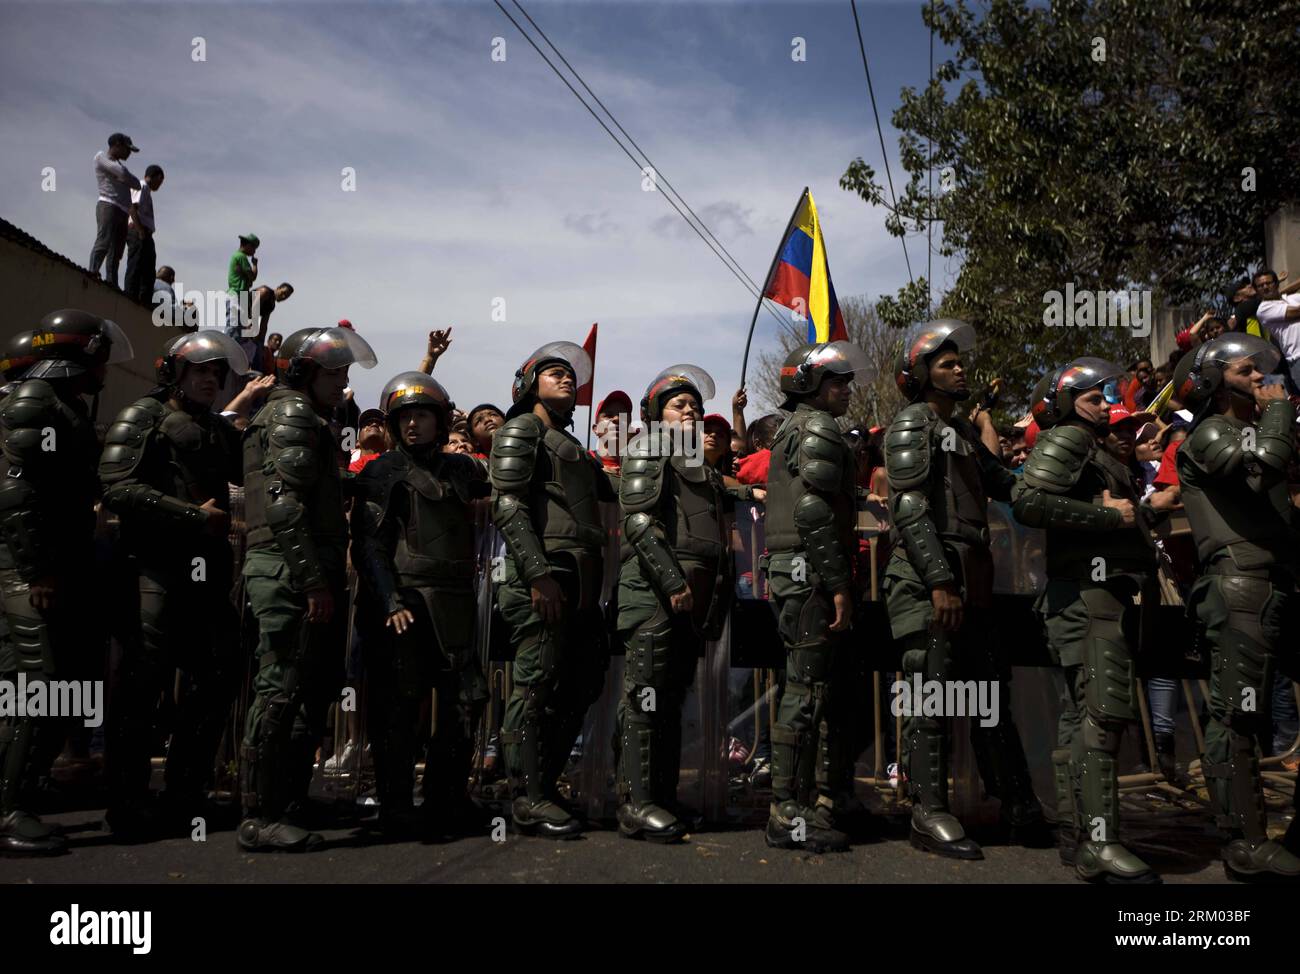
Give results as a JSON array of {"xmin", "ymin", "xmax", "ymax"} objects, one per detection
[{"xmin": 352, "ymin": 372, "xmax": 489, "ymax": 836}]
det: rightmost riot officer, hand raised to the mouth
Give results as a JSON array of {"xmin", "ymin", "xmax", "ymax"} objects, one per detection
[{"xmin": 1174, "ymin": 334, "xmax": 1300, "ymax": 879}]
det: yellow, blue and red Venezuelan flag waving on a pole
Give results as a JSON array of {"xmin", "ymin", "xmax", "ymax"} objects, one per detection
[{"xmin": 763, "ymin": 187, "xmax": 849, "ymax": 343}]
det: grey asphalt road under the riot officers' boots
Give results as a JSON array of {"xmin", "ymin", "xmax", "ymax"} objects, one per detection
[{"xmin": 0, "ymin": 802, "xmax": 1258, "ymax": 884}]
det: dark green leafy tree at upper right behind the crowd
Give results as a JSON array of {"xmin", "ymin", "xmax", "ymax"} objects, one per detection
[{"xmin": 840, "ymin": 0, "xmax": 1300, "ymax": 403}]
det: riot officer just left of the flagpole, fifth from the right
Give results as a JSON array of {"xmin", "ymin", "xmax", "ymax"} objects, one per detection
[{"xmin": 615, "ymin": 365, "xmax": 754, "ymax": 843}]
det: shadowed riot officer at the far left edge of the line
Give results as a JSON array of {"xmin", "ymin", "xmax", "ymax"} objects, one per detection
[{"xmin": 0, "ymin": 308, "xmax": 133, "ymax": 854}]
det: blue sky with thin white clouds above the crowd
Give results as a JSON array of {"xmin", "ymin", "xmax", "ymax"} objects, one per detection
[{"xmin": 0, "ymin": 0, "xmax": 943, "ymax": 418}]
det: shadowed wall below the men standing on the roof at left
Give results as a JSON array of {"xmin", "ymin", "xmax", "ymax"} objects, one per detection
[{"xmin": 0, "ymin": 238, "xmax": 178, "ymax": 423}]
